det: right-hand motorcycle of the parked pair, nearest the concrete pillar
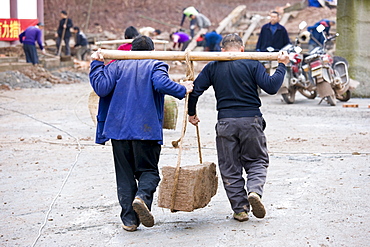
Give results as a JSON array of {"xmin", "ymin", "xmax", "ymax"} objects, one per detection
[{"xmin": 304, "ymin": 25, "xmax": 353, "ymax": 106}]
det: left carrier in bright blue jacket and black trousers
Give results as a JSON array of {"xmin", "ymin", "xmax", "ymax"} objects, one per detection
[{"xmin": 90, "ymin": 36, "xmax": 193, "ymax": 231}]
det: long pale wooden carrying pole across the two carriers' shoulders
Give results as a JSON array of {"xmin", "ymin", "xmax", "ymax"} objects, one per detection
[{"xmin": 100, "ymin": 49, "xmax": 279, "ymax": 61}]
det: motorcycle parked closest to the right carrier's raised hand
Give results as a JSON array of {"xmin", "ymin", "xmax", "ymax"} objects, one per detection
[{"xmin": 279, "ymin": 21, "xmax": 317, "ymax": 104}]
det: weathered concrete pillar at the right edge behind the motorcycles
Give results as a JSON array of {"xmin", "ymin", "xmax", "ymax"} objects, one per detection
[{"xmin": 335, "ymin": 0, "xmax": 370, "ymax": 97}]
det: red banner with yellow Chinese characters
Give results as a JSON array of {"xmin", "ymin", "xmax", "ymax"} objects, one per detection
[{"xmin": 0, "ymin": 19, "xmax": 38, "ymax": 41}]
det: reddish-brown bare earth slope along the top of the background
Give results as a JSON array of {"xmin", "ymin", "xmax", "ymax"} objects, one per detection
[{"xmin": 44, "ymin": 0, "xmax": 301, "ymax": 35}]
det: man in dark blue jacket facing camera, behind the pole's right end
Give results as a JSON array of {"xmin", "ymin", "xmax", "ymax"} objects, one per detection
[{"xmin": 256, "ymin": 11, "xmax": 290, "ymax": 52}]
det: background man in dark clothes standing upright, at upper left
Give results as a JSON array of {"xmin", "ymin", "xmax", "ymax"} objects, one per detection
[{"xmin": 55, "ymin": 10, "xmax": 73, "ymax": 56}]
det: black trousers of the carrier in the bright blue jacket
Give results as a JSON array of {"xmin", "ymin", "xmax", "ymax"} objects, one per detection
[{"xmin": 112, "ymin": 140, "xmax": 161, "ymax": 226}]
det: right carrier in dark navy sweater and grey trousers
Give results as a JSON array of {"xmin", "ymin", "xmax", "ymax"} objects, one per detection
[{"xmin": 188, "ymin": 34, "xmax": 289, "ymax": 221}]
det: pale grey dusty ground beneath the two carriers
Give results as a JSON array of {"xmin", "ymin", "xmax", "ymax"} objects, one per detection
[{"xmin": 0, "ymin": 65, "xmax": 370, "ymax": 247}]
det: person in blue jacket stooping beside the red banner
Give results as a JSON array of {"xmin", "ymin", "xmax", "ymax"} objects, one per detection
[{"xmin": 19, "ymin": 22, "xmax": 45, "ymax": 65}]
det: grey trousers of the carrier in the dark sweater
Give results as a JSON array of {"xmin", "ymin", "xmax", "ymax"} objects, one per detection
[{"xmin": 216, "ymin": 117, "xmax": 269, "ymax": 213}]
